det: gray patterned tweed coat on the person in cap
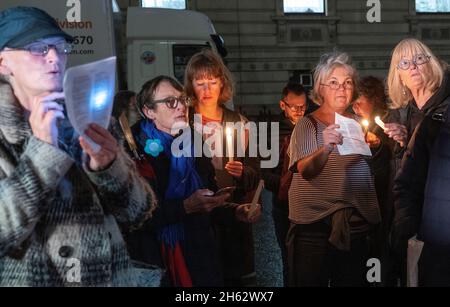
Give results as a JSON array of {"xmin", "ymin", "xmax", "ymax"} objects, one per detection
[{"xmin": 0, "ymin": 82, "xmax": 155, "ymax": 286}]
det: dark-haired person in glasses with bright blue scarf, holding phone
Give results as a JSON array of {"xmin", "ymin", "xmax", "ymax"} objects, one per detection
[{"xmin": 127, "ymin": 76, "xmax": 253, "ymax": 287}]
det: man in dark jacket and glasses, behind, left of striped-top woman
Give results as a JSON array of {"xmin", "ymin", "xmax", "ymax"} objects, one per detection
[{"xmin": 261, "ymin": 82, "xmax": 307, "ymax": 285}]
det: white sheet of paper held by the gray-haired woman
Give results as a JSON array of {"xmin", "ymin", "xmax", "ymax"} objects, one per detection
[{"xmin": 335, "ymin": 113, "xmax": 372, "ymax": 156}]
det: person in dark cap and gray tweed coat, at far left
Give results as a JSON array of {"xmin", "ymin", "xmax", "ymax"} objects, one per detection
[{"xmin": 0, "ymin": 7, "xmax": 159, "ymax": 286}]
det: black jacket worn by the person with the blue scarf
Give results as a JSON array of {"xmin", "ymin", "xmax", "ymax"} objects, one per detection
[{"xmin": 126, "ymin": 122, "xmax": 235, "ymax": 286}]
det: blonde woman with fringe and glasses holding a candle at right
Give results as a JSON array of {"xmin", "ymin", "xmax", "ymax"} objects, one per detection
[{"xmin": 385, "ymin": 38, "xmax": 450, "ymax": 285}]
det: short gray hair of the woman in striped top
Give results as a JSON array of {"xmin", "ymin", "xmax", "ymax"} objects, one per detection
[{"xmin": 309, "ymin": 50, "xmax": 358, "ymax": 105}]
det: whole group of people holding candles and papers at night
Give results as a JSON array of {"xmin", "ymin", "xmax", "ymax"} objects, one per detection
[{"xmin": 0, "ymin": 7, "xmax": 450, "ymax": 287}]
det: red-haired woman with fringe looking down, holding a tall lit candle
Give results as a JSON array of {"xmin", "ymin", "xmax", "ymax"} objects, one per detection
[{"xmin": 185, "ymin": 49, "xmax": 260, "ymax": 286}]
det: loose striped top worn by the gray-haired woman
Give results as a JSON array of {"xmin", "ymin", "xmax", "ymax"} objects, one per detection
[{"xmin": 289, "ymin": 116, "xmax": 380, "ymax": 224}]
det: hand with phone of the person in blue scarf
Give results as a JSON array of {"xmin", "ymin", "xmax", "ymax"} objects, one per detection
[{"xmin": 183, "ymin": 189, "xmax": 231, "ymax": 214}]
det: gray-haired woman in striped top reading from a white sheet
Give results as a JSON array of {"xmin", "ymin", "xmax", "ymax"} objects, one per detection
[{"xmin": 287, "ymin": 52, "xmax": 380, "ymax": 287}]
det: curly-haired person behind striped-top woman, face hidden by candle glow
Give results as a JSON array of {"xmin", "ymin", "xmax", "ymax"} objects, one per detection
[{"xmin": 353, "ymin": 76, "xmax": 403, "ymax": 286}]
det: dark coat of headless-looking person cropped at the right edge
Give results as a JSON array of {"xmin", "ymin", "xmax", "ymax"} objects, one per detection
[{"xmin": 392, "ymin": 103, "xmax": 450, "ymax": 287}]
